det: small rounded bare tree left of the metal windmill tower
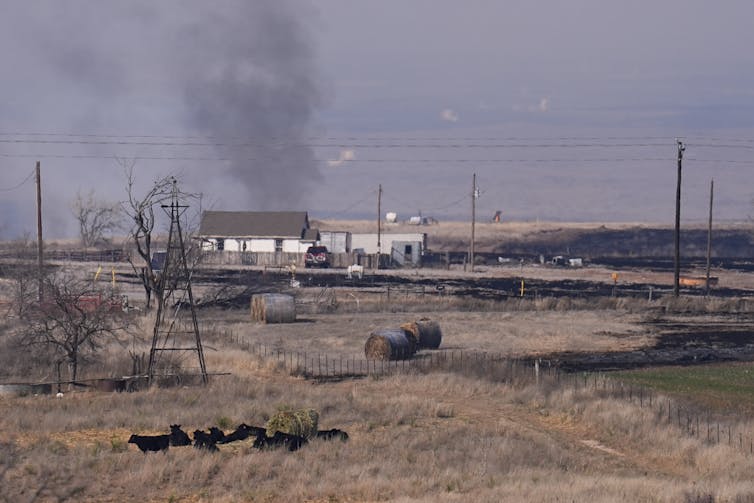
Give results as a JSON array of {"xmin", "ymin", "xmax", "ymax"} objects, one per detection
[{"xmin": 21, "ymin": 274, "xmax": 129, "ymax": 381}]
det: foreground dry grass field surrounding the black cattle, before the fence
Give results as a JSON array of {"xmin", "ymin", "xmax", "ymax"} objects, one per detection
[{"xmin": 0, "ymin": 348, "xmax": 754, "ymax": 501}]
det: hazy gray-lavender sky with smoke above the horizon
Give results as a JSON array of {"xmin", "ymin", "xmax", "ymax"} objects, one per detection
[{"xmin": 0, "ymin": 0, "xmax": 754, "ymax": 236}]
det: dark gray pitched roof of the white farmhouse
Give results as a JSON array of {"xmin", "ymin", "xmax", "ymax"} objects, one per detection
[{"xmin": 199, "ymin": 211, "xmax": 309, "ymax": 239}]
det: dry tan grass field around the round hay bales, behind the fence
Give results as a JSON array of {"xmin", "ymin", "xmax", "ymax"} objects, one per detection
[{"xmin": 206, "ymin": 311, "xmax": 652, "ymax": 358}]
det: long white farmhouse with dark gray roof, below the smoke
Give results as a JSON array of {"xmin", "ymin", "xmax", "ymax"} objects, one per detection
[{"xmin": 197, "ymin": 211, "xmax": 319, "ymax": 253}]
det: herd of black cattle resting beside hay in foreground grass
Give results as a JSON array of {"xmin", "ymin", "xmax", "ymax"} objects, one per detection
[{"xmin": 128, "ymin": 423, "xmax": 348, "ymax": 454}]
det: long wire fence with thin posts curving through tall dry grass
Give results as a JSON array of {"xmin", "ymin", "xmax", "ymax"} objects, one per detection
[{"xmin": 225, "ymin": 331, "xmax": 754, "ymax": 456}]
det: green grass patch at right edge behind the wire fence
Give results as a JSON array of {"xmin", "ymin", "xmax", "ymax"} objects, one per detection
[{"xmin": 615, "ymin": 363, "xmax": 754, "ymax": 413}]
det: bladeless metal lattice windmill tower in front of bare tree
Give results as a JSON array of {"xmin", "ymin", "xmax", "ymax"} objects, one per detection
[{"xmin": 148, "ymin": 179, "xmax": 208, "ymax": 385}]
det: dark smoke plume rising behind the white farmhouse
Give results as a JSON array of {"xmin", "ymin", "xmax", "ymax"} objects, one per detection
[{"xmin": 182, "ymin": 0, "xmax": 321, "ymax": 210}]
